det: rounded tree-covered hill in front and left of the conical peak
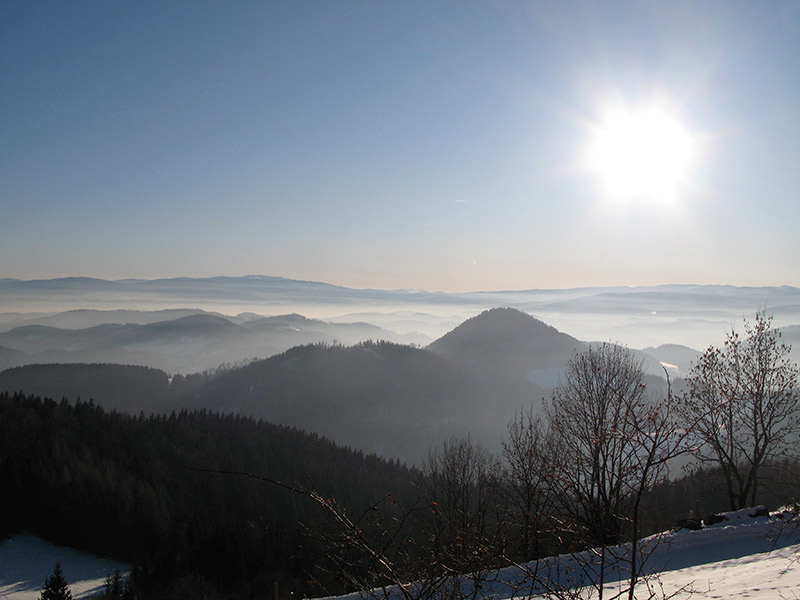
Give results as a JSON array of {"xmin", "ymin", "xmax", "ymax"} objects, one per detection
[{"xmin": 189, "ymin": 342, "xmax": 482, "ymax": 461}]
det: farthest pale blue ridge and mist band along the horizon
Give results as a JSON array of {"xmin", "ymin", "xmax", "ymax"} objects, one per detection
[{"xmin": 0, "ymin": 275, "xmax": 800, "ymax": 348}]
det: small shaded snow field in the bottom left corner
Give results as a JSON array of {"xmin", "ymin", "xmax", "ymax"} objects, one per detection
[{"xmin": 0, "ymin": 535, "xmax": 130, "ymax": 600}]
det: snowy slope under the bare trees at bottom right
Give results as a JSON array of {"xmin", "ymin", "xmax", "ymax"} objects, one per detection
[{"xmin": 324, "ymin": 509, "xmax": 800, "ymax": 600}]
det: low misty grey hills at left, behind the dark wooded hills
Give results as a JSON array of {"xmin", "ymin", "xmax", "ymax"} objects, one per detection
[{"xmin": 0, "ymin": 311, "xmax": 426, "ymax": 373}]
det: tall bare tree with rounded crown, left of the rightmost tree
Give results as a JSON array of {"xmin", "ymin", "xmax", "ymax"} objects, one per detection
[{"xmin": 546, "ymin": 344, "xmax": 684, "ymax": 600}]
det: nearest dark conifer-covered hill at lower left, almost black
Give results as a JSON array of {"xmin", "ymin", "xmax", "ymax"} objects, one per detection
[{"xmin": 0, "ymin": 393, "xmax": 415, "ymax": 595}]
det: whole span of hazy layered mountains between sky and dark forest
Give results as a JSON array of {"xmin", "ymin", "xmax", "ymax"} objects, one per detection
[{"xmin": 0, "ymin": 276, "xmax": 800, "ymax": 464}]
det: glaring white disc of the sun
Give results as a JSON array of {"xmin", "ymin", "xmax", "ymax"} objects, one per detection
[{"xmin": 589, "ymin": 109, "xmax": 692, "ymax": 201}]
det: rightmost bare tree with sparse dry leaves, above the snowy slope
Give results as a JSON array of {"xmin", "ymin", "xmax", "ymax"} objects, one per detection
[{"xmin": 680, "ymin": 311, "xmax": 800, "ymax": 510}]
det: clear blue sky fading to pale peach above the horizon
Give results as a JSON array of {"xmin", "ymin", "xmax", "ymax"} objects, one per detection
[{"xmin": 0, "ymin": 0, "xmax": 800, "ymax": 291}]
